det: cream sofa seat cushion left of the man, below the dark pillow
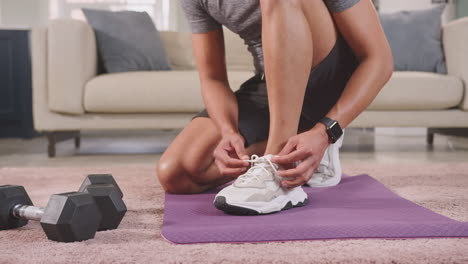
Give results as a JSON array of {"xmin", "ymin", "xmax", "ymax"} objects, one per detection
[{"xmin": 84, "ymin": 71, "xmax": 253, "ymax": 113}]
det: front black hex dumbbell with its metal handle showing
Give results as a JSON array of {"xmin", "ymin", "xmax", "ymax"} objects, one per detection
[{"xmin": 0, "ymin": 185, "xmax": 102, "ymax": 242}]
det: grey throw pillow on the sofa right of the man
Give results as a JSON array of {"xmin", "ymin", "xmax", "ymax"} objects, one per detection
[{"xmin": 380, "ymin": 5, "xmax": 447, "ymax": 73}]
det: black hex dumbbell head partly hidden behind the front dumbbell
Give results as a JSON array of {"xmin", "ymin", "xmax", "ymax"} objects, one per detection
[{"xmin": 78, "ymin": 174, "xmax": 127, "ymax": 231}]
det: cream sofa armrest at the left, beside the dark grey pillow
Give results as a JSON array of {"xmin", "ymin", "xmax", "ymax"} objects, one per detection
[{"xmin": 47, "ymin": 19, "xmax": 97, "ymax": 114}]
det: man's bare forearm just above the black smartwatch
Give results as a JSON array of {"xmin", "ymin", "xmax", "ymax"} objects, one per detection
[{"xmin": 327, "ymin": 57, "xmax": 393, "ymax": 128}]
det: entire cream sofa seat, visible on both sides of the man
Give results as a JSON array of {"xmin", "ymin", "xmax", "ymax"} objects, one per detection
[{"xmin": 84, "ymin": 71, "xmax": 463, "ymax": 113}]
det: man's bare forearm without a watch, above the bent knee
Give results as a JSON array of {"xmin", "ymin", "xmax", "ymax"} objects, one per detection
[{"xmin": 202, "ymin": 80, "xmax": 238, "ymax": 134}]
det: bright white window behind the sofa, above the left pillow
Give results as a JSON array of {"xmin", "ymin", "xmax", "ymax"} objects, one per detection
[{"xmin": 49, "ymin": 0, "xmax": 171, "ymax": 30}]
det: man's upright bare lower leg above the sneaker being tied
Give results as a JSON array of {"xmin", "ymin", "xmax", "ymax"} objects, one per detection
[{"xmin": 260, "ymin": 0, "xmax": 336, "ymax": 154}]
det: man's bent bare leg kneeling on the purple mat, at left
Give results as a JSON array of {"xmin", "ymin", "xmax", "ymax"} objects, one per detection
[{"xmin": 157, "ymin": 117, "xmax": 266, "ymax": 193}]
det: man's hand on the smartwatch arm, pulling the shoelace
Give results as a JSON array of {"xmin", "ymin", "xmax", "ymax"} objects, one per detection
[{"xmin": 272, "ymin": 123, "xmax": 330, "ymax": 189}]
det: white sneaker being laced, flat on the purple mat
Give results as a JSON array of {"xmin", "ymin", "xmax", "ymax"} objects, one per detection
[{"xmin": 213, "ymin": 155, "xmax": 308, "ymax": 215}]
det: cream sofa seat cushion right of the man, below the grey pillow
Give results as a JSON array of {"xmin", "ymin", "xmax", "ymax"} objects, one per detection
[{"xmin": 368, "ymin": 72, "xmax": 463, "ymax": 111}]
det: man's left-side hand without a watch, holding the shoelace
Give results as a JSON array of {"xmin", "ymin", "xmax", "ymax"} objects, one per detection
[{"xmin": 213, "ymin": 132, "xmax": 250, "ymax": 177}]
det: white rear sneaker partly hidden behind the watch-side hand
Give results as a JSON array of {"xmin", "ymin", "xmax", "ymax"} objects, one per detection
[{"xmin": 307, "ymin": 130, "xmax": 344, "ymax": 187}]
